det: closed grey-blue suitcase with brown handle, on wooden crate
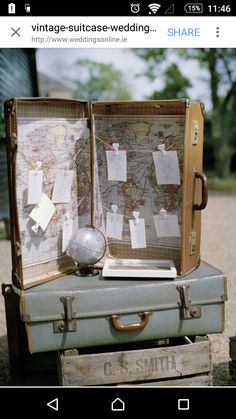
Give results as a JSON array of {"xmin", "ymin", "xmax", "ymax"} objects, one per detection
[{"xmin": 15, "ymin": 262, "xmax": 227, "ymax": 353}]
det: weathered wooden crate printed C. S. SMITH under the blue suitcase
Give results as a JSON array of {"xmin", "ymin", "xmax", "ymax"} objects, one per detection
[{"xmin": 58, "ymin": 336, "xmax": 212, "ymax": 386}]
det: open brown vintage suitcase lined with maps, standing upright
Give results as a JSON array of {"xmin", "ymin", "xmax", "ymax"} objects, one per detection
[{"xmin": 5, "ymin": 98, "xmax": 207, "ymax": 289}]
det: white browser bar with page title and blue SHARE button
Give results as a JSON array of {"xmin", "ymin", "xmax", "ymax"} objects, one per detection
[{"xmin": 0, "ymin": 16, "xmax": 236, "ymax": 48}]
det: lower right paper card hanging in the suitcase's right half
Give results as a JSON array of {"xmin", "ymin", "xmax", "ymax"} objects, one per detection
[{"xmin": 153, "ymin": 214, "xmax": 180, "ymax": 237}]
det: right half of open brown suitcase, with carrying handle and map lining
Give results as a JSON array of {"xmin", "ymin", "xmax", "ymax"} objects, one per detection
[{"xmin": 91, "ymin": 100, "xmax": 207, "ymax": 276}]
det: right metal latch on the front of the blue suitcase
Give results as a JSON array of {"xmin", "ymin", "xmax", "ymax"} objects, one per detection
[{"xmin": 176, "ymin": 285, "xmax": 202, "ymax": 320}]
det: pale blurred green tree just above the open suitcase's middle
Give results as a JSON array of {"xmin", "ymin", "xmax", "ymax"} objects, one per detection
[{"xmin": 74, "ymin": 59, "xmax": 131, "ymax": 101}]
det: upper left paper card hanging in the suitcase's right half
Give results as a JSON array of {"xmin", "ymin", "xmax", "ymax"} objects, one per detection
[{"xmin": 106, "ymin": 150, "xmax": 127, "ymax": 182}]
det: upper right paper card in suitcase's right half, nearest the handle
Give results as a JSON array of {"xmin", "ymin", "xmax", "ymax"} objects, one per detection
[{"xmin": 152, "ymin": 151, "xmax": 180, "ymax": 185}]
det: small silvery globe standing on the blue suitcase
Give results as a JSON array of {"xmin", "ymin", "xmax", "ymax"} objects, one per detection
[{"xmin": 67, "ymin": 227, "xmax": 106, "ymax": 266}]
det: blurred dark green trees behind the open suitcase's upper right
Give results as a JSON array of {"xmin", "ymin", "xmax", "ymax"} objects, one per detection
[{"xmin": 133, "ymin": 48, "xmax": 236, "ymax": 178}]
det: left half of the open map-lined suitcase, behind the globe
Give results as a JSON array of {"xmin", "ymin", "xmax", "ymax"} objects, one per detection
[{"xmin": 5, "ymin": 98, "xmax": 91, "ymax": 288}]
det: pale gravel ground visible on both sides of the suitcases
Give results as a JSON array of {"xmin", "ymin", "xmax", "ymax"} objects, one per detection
[{"xmin": 0, "ymin": 195, "xmax": 236, "ymax": 386}]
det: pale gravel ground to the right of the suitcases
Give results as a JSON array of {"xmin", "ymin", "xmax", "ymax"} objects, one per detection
[{"xmin": 201, "ymin": 195, "xmax": 236, "ymax": 386}]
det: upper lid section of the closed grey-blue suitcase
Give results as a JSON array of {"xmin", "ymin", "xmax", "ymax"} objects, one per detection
[{"xmin": 18, "ymin": 262, "xmax": 227, "ymax": 322}]
